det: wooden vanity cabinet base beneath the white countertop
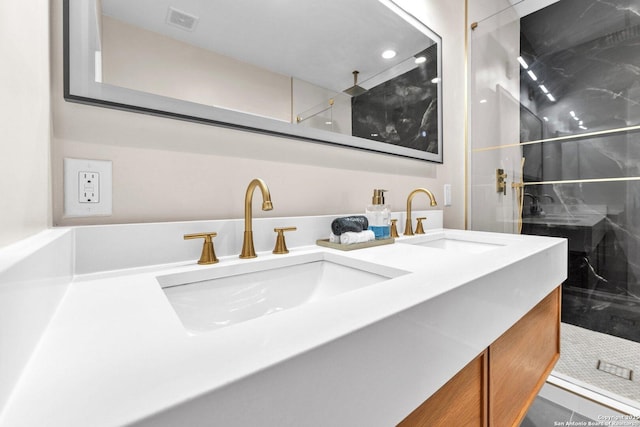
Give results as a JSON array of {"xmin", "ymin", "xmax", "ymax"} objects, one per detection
[{"xmin": 398, "ymin": 287, "xmax": 561, "ymax": 427}]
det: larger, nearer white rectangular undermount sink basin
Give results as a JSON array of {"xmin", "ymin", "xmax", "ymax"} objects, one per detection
[{"xmin": 157, "ymin": 253, "xmax": 406, "ymax": 333}]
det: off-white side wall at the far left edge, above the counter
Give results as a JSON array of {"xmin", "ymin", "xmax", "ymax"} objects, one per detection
[{"xmin": 0, "ymin": 0, "xmax": 50, "ymax": 247}]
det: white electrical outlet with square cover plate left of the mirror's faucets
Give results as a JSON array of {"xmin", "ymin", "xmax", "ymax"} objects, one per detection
[{"xmin": 64, "ymin": 158, "xmax": 112, "ymax": 217}]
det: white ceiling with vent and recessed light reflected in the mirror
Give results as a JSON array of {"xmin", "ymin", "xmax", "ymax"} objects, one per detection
[{"xmin": 102, "ymin": 0, "xmax": 433, "ymax": 91}]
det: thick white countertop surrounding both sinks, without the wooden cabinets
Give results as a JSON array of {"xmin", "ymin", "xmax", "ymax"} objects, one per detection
[{"xmin": 0, "ymin": 219, "xmax": 567, "ymax": 427}]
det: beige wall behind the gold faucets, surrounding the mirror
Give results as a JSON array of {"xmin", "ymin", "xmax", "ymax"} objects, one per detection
[{"xmin": 52, "ymin": 0, "xmax": 465, "ymax": 228}]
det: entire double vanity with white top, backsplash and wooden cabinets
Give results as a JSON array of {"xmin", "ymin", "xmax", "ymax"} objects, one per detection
[{"xmin": 0, "ymin": 210, "xmax": 567, "ymax": 427}]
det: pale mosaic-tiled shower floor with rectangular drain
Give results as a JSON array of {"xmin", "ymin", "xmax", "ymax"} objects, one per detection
[{"xmin": 555, "ymin": 323, "xmax": 640, "ymax": 407}]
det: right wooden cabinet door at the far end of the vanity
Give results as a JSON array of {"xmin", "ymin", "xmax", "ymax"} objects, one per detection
[{"xmin": 489, "ymin": 288, "xmax": 560, "ymax": 427}]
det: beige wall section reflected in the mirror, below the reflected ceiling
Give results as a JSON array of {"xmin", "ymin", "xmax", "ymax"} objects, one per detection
[{"xmin": 102, "ymin": 16, "xmax": 291, "ymax": 122}]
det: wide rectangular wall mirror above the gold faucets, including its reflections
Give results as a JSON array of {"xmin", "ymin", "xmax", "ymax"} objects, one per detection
[{"xmin": 66, "ymin": 0, "xmax": 442, "ymax": 161}]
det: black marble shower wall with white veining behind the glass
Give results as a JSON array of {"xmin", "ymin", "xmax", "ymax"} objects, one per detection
[{"xmin": 520, "ymin": 0, "xmax": 640, "ymax": 342}]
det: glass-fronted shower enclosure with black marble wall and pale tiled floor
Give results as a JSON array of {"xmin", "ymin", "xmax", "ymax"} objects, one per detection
[{"xmin": 468, "ymin": 0, "xmax": 640, "ymax": 408}]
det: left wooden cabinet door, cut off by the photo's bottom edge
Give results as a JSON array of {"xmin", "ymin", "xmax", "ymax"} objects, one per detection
[{"xmin": 398, "ymin": 351, "xmax": 487, "ymax": 427}]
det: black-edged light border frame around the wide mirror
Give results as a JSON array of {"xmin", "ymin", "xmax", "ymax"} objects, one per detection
[{"xmin": 63, "ymin": 0, "xmax": 443, "ymax": 163}]
